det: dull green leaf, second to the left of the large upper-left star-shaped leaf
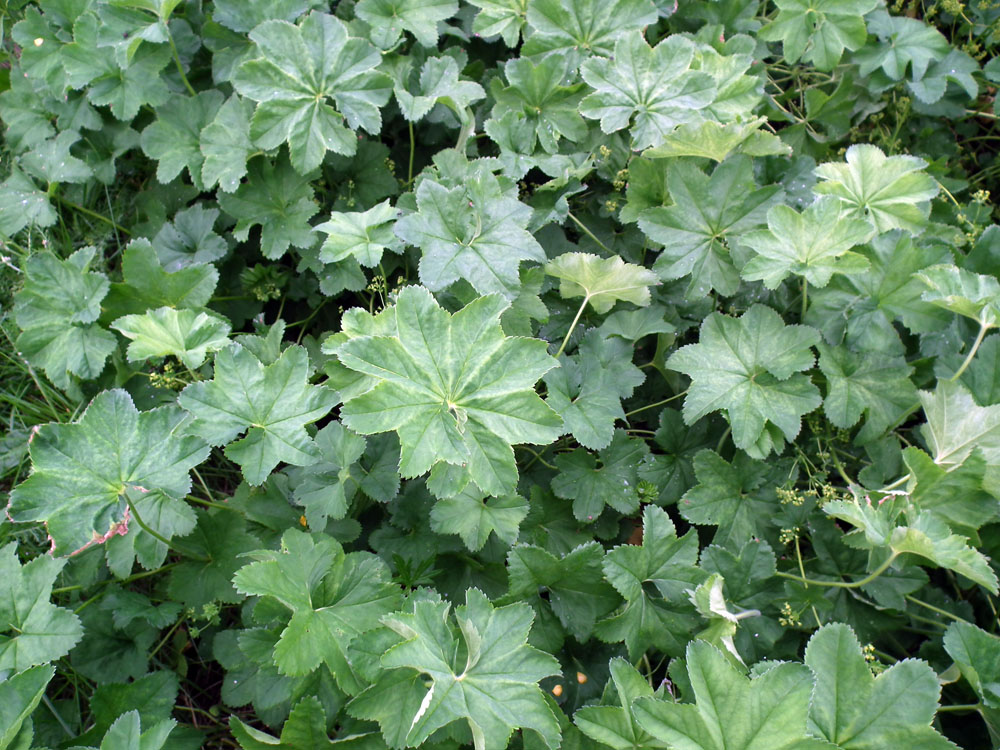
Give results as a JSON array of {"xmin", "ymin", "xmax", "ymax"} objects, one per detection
[{"xmin": 142, "ymin": 90, "xmax": 224, "ymax": 187}]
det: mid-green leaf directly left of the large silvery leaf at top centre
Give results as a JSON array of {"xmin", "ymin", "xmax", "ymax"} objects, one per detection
[{"xmin": 491, "ymin": 53, "xmax": 587, "ymax": 154}]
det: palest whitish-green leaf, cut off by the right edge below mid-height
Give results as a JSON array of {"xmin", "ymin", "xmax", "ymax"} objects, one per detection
[{"xmin": 918, "ymin": 380, "xmax": 1000, "ymax": 468}]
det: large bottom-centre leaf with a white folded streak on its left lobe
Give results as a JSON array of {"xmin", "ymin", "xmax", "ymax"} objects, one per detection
[{"xmin": 361, "ymin": 589, "xmax": 559, "ymax": 750}]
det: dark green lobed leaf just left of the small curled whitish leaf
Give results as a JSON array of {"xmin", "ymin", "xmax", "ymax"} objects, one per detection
[{"xmin": 596, "ymin": 505, "xmax": 706, "ymax": 659}]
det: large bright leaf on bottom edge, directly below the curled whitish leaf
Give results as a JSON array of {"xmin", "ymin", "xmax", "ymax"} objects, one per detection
[{"xmin": 632, "ymin": 640, "xmax": 830, "ymax": 750}]
